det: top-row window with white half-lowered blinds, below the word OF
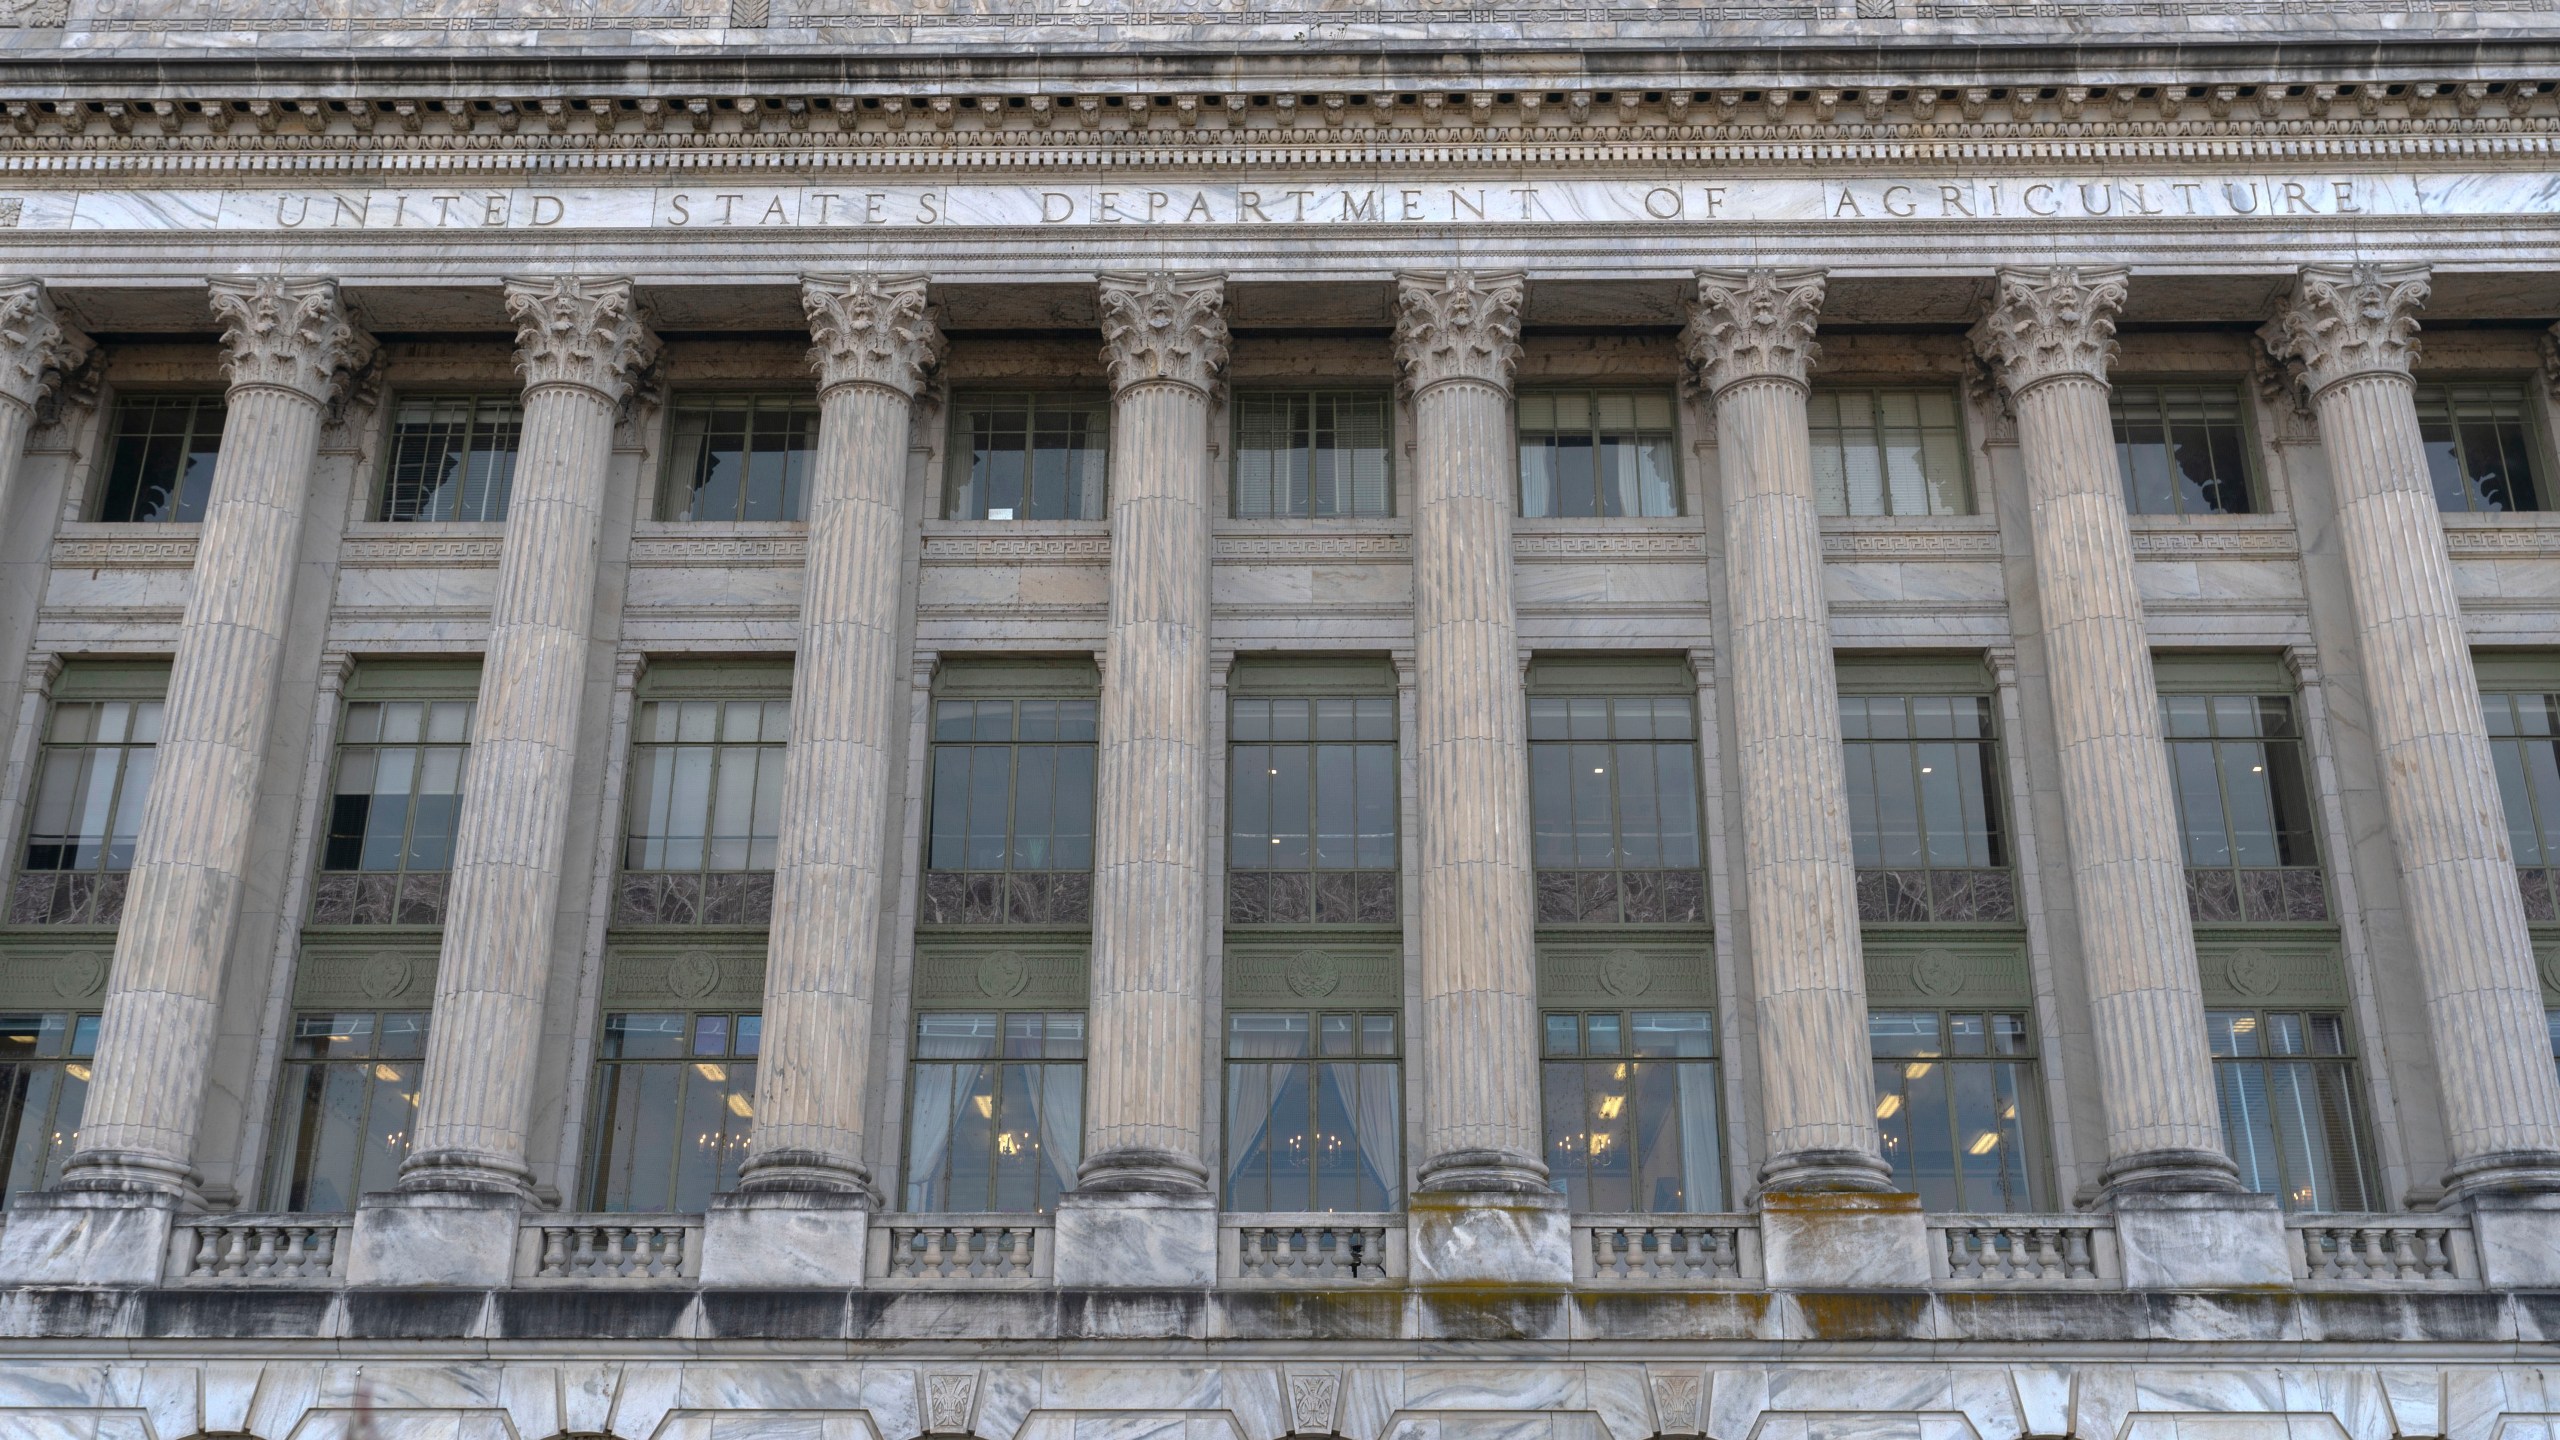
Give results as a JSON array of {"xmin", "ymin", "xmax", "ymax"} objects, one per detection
[{"xmin": 1518, "ymin": 389, "xmax": 1679, "ymax": 520}]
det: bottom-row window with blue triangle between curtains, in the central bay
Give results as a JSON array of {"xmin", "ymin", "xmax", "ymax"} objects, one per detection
[{"xmin": 1226, "ymin": 1010, "xmax": 1405, "ymax": 1212}]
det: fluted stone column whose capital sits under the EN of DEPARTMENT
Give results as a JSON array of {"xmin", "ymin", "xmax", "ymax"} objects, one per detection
[{"xmin": 1395, "ymin": 272, "xmax": 1546, "ymax": 1194}]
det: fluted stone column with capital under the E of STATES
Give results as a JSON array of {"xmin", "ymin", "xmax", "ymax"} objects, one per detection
[{"xmin": 740, "ymin": 274, "xmax": 942, "ymax": 1199}]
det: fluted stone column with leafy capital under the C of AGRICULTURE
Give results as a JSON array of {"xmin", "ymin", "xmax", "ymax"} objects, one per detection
[{"xmin": 1974, "ymin": 266, "xmax": 2237, "ymax": 1194}]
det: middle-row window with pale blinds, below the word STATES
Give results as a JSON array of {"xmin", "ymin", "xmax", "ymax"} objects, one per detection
[{"xmin": 614, "ymin": 700, "xmax": 791, "ymax": 925}]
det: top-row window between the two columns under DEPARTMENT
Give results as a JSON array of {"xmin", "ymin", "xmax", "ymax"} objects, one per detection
[{"xmin": 1236, "ymin": 389, "xmax": 1390, "ymax": 520}]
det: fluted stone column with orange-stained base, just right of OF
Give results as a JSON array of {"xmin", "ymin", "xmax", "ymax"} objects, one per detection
[{"xmin": 1682, "ymin": 269, "xmax": 1892, "ymax": 1191}]
